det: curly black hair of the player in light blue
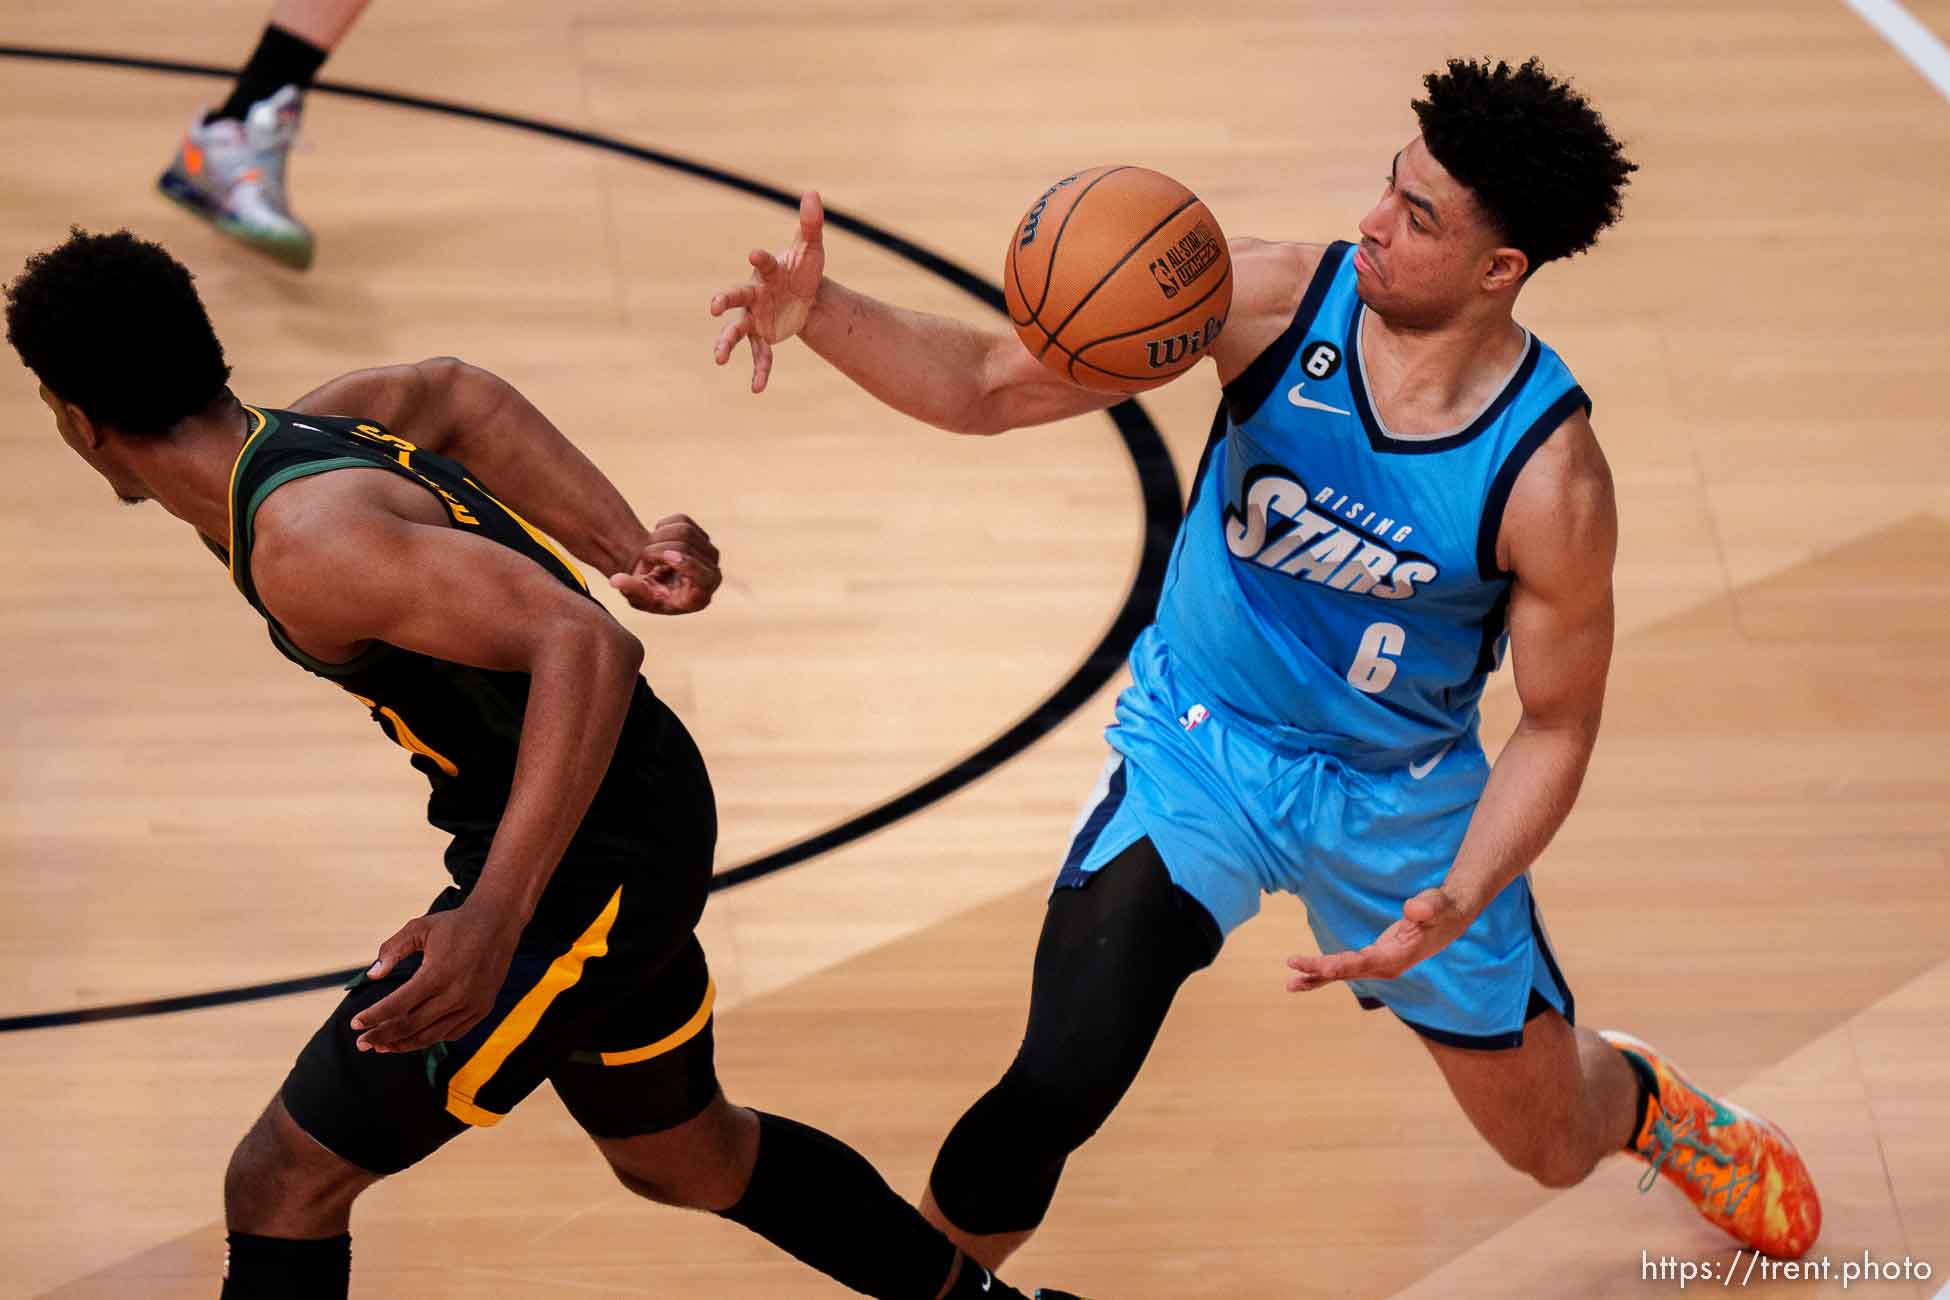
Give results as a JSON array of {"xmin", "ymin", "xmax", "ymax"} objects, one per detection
[{"xmin": 1414, "ymin": 57, "xmax": 1638, "ymax": 269}]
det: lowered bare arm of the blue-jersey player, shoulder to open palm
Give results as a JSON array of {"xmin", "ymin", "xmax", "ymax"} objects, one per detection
[{"xmin": 1287, "ymin": 413, "xmax": 1619, "ymax": 992}]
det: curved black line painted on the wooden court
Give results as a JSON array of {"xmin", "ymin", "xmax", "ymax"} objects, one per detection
[{"xmin": 0, "ymin": 45, "xmax": 1184, "ymax": 1033}]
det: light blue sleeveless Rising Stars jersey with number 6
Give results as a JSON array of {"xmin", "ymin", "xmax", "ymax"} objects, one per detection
[{"xmin": 1133, "ymin": 244, "xmax": 1589, "ymax": 768}]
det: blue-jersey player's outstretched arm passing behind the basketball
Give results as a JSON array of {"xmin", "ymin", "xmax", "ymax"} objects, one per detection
[{"xmin": 710, "ymin": 193, "xmax": 1322, "ymax": 435}]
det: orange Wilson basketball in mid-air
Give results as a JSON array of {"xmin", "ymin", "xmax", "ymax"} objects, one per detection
[{"xmin": 1002, "ymin": 166, "xmax": 1232, "ymax": 394}]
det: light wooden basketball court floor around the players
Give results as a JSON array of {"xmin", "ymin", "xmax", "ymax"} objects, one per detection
[{"xmin": 0, "ymin": 0, "xmax": 1950, "ymax": 1300}]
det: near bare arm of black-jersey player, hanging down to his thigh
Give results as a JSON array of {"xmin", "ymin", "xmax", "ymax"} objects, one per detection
[{"xmin": 252, "ymin": 470, "xmax": 644, "ymax": 1051}]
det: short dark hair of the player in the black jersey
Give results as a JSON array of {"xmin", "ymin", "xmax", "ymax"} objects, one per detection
[{"xmin": 6, "ymin": 226, "xmax": 230, "ymax": 435}]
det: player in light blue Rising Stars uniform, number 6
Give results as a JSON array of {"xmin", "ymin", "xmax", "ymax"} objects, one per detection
[{"xmin": 712, "ymin": 60, "xmax": 1821, "ymax": 1267}]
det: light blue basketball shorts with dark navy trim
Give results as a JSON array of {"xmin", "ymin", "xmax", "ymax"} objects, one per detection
[{"xmin": 1057, "ymin": 650, "xmax": 1574, "ymax": 1049}]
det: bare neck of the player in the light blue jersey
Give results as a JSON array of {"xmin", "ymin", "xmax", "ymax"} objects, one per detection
[{"xmin": 1357, "ymin": 306, "xmax": 1529, "ymax": 435}]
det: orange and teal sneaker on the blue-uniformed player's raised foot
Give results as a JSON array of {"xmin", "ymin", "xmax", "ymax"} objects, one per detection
[{"xmin": 1601, "ymin": 1029, "xmax": 1821, "ymax": 1259}]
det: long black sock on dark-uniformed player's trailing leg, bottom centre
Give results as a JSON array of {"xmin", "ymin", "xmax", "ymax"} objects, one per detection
[{"xmin": 723, "ymin": 1111, "xmax": 1024, "ymax": 1300}]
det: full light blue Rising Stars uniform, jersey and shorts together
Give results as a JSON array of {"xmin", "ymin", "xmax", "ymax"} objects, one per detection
[{"xmin": 1057, "ymin": 244, "xmax": 1589, "ymax": 1049}]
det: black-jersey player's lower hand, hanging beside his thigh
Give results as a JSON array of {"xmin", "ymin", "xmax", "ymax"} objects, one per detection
[{"xmin": 353, "ymin": 904, "xmax": 521, "ymax": 1052}]
